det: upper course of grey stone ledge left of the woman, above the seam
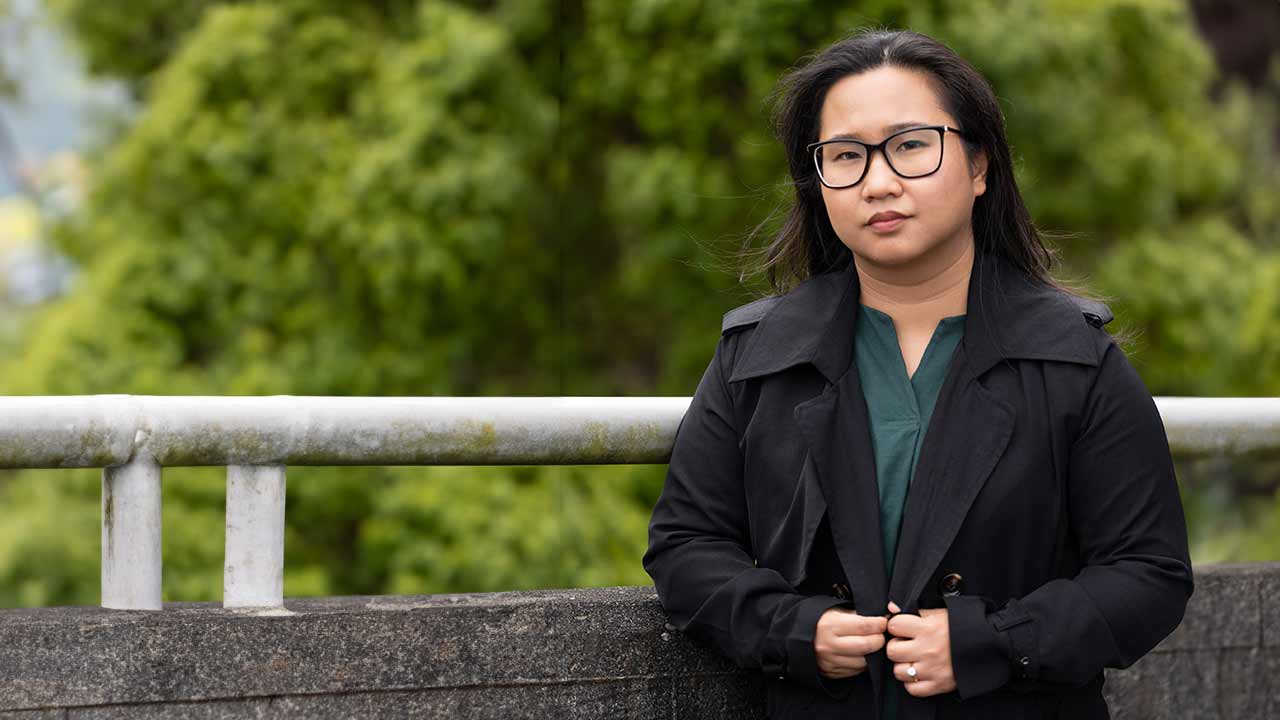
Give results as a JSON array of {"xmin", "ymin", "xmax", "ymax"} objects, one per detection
[{"xmin": 0, "ymin": 587, "xmax": 739, "ymax": 710}]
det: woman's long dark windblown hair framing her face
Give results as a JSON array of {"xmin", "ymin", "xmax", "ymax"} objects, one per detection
[{"xmin": 740, "ymin": 29, "xmax": 1079, "ymax": 293}]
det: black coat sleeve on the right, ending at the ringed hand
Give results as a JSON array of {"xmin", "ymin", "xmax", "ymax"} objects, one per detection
[{"xmin": 945, "ymin": 341, "xmax": 1194, "ymax": 700}]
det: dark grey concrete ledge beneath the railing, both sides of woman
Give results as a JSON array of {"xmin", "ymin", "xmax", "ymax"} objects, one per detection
[{"xmin": 0, "ymin": 562, "xmax": 1280, "ymax": 719}]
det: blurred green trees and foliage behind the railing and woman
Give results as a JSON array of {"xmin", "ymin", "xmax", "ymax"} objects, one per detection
[{"xmin": 0, "ymin": 0, "xmax": 1280, "ymax": 607}]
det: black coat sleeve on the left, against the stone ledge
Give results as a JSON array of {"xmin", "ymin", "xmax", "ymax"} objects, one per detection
[{"xmin": 643, "ymin": 333, "xmax": 851, "ymax": 697}]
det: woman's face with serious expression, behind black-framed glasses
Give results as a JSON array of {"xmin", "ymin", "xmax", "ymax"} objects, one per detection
[{"xmin": 818, "ymin": 65, "xmax": 987, "ymax": 270}]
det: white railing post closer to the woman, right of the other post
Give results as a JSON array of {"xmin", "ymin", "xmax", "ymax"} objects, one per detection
[{"xmin": 223, "ymin": 465, "xmax": 284, "ymax": 607}]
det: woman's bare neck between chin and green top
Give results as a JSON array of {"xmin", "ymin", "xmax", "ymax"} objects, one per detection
[{"xmin": 855, "ymin": 242, "xmax": 974, "ymax": 328}]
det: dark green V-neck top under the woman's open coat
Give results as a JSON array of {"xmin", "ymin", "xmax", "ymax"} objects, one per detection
[{"xmin": 854, "ymin": 304, "xmax": 964, "ymax": 720}]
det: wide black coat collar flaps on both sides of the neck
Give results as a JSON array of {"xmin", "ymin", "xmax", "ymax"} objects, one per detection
[{"xmin": 730, "ymin": 245, "xmax": 1111, "ymax": 383}]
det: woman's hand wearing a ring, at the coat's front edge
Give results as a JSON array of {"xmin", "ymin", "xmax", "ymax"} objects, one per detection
[{"xmin": 884, "ymin": 601, "xmax": 956, "ymax": 697}]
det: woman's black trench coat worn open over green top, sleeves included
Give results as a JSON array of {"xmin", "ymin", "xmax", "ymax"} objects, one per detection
[{"xmin": 644, "ymin": 254, "xmax": 1193, "ymax": 720}]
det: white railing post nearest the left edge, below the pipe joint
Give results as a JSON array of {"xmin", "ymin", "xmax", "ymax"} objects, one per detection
[{"xmin": 102, "ymin": 455, "xmax": 161, "ymax": 610}]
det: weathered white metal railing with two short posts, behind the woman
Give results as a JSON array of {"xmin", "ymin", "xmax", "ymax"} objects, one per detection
[{"xmin": 0, "ymin": 395, "xmax": 1280, "ymax": 610}]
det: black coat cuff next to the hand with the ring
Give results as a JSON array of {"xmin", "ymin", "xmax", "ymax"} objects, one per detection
[{"xmin": 942, "ymin": 594, "xmax": 1012, "ymax": 700}]
